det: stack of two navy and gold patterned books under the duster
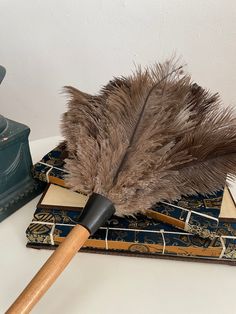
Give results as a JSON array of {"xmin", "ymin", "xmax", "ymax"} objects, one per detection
[{"xmin": 26, "ymin": 143, "xmax": 236, "ymax": 265}]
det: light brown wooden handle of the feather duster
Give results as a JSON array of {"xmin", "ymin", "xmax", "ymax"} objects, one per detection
[{"xmin": 6, "ymin": 225, "xmax": 90, "ymax": 314}]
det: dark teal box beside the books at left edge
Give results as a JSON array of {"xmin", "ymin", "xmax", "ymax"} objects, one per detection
[{"xmin": 0, "ymin": 115, "xmax": 45, "ymax": 221}]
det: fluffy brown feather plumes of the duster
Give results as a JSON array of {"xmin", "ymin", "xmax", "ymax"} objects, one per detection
[{"xmin": 62, "ymin": 62, "xmax": 236, "ymax": 215}]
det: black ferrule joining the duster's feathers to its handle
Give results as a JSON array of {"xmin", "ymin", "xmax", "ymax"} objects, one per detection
[{"xmin": 79, "ymin": 193, "xmax": 115, "ymax": 234}]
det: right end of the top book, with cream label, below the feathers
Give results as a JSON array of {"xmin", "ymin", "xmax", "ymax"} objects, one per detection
[{"xmin": 148, "ymin": 185, "xmax": 236, "ymax": 239}]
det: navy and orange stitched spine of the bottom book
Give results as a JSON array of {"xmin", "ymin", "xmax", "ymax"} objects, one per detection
[{"xmin": 26, "ymin": 221, "xmax": 236, "ymax": 260}]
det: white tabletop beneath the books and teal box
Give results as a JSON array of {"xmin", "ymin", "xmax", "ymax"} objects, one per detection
[{"xmin": 0, "ymin": 137, "xmax": 236, "ymax": 314}]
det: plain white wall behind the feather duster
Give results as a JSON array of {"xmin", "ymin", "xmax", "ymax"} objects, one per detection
[{"xmin": 0, "ymin": 0, "xmax": 236, "ymax": 139}]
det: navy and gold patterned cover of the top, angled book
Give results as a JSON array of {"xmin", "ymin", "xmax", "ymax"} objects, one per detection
[{"xmin": 33, "ymin": 146, "xmax": 226, "ymax": 239}]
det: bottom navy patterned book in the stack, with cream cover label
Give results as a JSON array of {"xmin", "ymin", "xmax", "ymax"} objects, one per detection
[{"xmin": 26, "ymin": 185, "xmax": 236, "ymax": 265}]
